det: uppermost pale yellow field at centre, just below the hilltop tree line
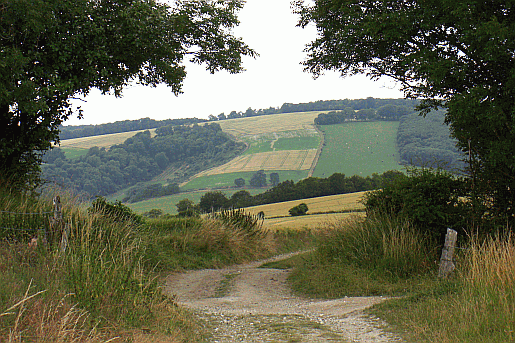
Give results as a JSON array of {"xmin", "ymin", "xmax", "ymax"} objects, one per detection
[{"xmin": 217, "ymin": 111, "xmax": 326, "ymax": 138}]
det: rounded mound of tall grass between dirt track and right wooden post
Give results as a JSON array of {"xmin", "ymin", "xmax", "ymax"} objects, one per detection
[{"xmin": 291, "ymin": 217, "xmax": 437, "ymax": 298}]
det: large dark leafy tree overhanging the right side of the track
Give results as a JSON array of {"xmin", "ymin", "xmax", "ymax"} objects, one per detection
[{"xmin": 295, "ymin": 0, "xmax": 515, "ymax": 224}]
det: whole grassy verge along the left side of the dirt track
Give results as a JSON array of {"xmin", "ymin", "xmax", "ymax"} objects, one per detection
[{"xmin": 0, "ymin": 190, "xmax": 310, "ymax": 342}]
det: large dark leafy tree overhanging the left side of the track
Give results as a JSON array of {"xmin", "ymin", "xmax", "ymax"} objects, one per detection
[{"xmin": 0, "ymin": 0, "xmax": 256, "ymax": 187}]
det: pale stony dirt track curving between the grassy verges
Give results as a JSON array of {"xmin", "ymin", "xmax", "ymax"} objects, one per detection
[{"xmin": 167, "ymin": 255, "xmax": 402, "ymax": 343}]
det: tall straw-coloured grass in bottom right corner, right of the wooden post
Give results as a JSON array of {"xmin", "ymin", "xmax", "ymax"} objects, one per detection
[{"xmin": 377, "ymin": 234, "xmax": 515, "ymax": 343}]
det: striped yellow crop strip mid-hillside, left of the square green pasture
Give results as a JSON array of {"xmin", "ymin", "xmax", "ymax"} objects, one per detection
[{"xmin": 196, "ymin": 149, "xmax": 317, "ymax": 177}]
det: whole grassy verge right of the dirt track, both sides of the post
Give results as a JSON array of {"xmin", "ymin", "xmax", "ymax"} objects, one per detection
[{"xmin": 279, "ymin": 214, "xmax": 515, "ymax": 342}]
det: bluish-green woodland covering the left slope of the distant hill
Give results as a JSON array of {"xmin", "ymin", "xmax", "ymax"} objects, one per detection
[{"xmin": 42, "ymin": 123, "xmax": 245, "ymax": 196}]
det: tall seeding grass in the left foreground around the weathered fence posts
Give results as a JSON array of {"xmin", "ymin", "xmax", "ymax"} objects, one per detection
[{"xmin": 0, "ymin": 190, "xmax": 177, "ymax": 342}]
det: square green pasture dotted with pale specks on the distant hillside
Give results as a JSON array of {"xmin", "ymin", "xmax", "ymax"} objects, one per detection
[{"xmin": 313, "ymin": 121, "xmax": 402, "ymax": 177}]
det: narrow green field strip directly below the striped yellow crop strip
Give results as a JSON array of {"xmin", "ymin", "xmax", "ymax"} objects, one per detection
[{"xmin": 181, "ymin": 170, "xmax": 308, "ymax": 190}]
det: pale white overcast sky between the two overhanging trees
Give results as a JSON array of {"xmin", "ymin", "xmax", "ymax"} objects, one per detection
[{"xmin": 64, "ymin": 0, "xmax": 403, "ymax": 125}]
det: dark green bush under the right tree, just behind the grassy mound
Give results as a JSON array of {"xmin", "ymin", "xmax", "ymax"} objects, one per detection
[{"xmin": 364, "ymin": 167, "xmax": 471, "ymax": 237}]
